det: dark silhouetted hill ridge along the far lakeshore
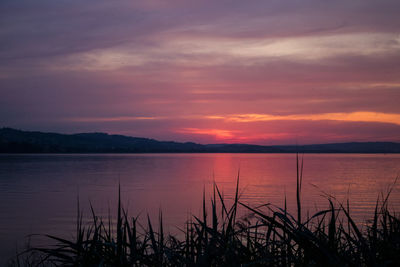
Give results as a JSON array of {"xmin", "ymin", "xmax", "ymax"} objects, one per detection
[{"xmin": 0, "ymin": 128, "xmax": 400, "ymax": 153}]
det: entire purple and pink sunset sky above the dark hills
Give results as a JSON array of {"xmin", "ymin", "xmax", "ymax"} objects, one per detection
[{"xmin": 0, "ymin": 0, "xmax": 400, "ymax": 145}]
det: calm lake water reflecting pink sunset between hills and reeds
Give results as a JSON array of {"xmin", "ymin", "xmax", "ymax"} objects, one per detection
[{"xmin": 0, "ymin": 154, "xmax": 400, "ymax": 264}]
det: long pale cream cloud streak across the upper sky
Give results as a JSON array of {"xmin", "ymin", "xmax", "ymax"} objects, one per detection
[{"xmin": 21, "ymin": 33, "xmax": 400, "ymax": 71}]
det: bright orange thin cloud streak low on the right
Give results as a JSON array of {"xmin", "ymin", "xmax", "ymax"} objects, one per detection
[{"xmin": 207, "ymin": 111, "xmax": 400, "ymax": 125}]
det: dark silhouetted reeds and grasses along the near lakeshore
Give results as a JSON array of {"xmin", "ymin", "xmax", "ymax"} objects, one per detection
[{"xmin": 9, "ymin": 157, "xmax": 400, "ymax": 266}]
